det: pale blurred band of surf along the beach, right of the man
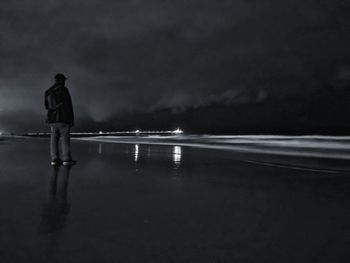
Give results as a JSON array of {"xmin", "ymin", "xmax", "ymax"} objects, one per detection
[{"xmin": 78, "ymin": 135, "xmax": 350, "ymax": 160}]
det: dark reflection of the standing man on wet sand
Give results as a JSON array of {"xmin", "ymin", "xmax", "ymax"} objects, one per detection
[{"xmin": 39, "ymin": 165, "xmax": 72, "ymax": 234}]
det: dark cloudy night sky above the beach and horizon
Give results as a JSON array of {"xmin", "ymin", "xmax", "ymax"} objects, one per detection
[{"xmin": 0, "ymin": 0, "xmax": 350, "ymax": 133}]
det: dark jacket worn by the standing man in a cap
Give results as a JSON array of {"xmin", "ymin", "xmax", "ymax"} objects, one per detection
[{"xmin": 45, "ymin": 83, "xmax": 74, "ymax": 126}]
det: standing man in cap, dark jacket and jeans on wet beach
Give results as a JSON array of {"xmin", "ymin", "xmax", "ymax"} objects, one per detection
[{"xmin": 45, "ymin": 73, "xmax": 76, "ymax": 165}]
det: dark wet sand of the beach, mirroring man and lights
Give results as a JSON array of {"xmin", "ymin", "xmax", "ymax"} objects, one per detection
[{"xmin": 0, "ymin": 139, "xmax": 350, "ymax": 263}]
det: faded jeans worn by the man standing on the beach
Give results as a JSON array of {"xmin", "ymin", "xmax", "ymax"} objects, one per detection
[{"xmin": 50, "ymin": 123, "xmax": 71, "ymax": 161}]
